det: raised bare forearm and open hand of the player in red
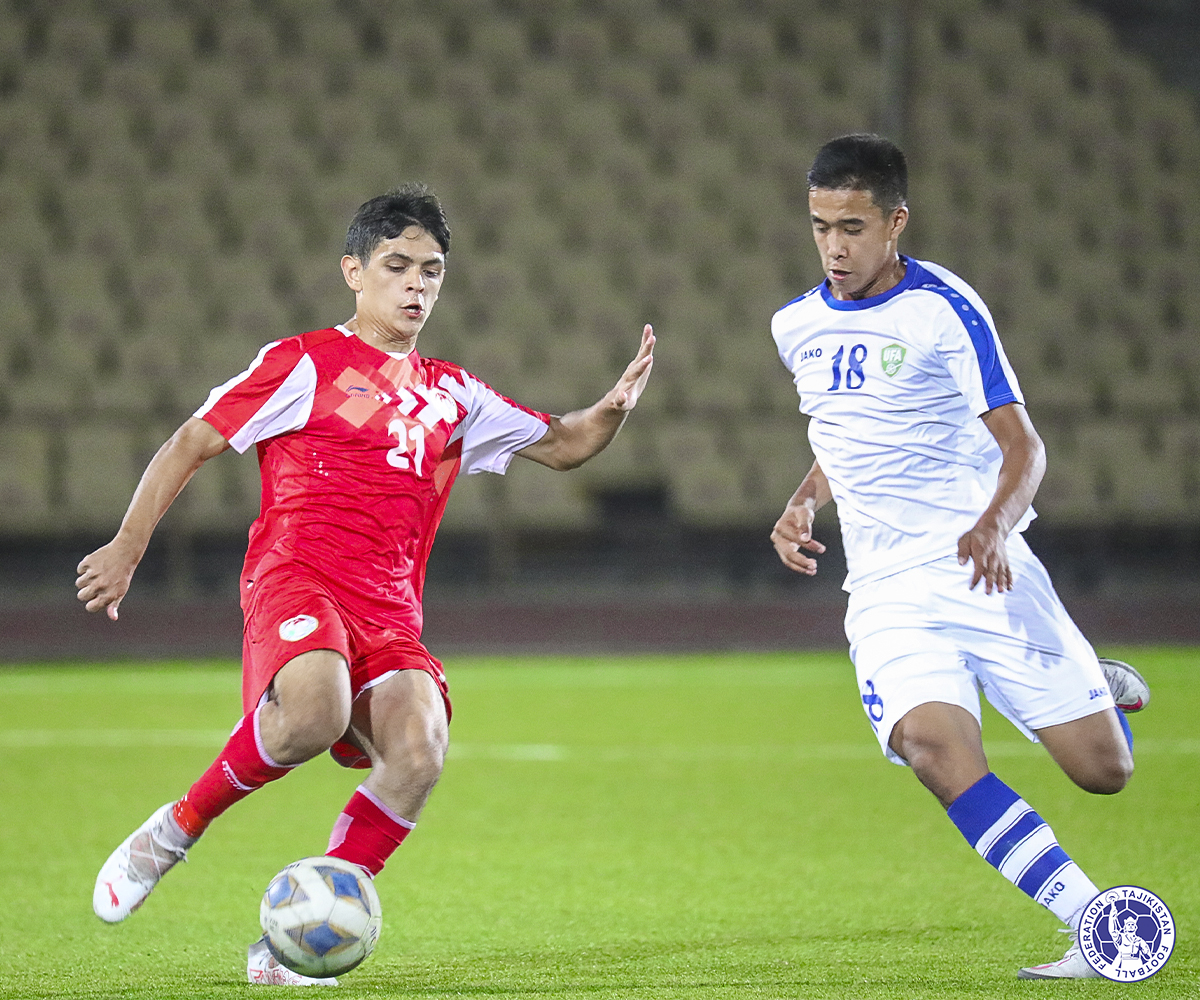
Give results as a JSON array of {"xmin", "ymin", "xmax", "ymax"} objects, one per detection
[{"xmin": 517, "ymin": 324, "xmax": 654, "ymax": 472}]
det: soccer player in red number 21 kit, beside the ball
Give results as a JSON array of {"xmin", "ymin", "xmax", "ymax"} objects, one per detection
[{"xmin": 77, "ymin": 185, "xmax": 654, "ymax": 984}]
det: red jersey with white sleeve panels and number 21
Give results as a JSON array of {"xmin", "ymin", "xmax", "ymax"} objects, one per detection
[{"xmin": 196, "ymin": 327, "xmax": 550, "ymax": 637}]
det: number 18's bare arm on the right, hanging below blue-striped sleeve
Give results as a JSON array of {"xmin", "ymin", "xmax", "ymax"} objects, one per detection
[{"xmin": 959, "ymin": 403, "xmax": 1046, "ymax": 594}]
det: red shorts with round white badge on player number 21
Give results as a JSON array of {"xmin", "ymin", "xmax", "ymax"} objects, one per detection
[{"xmin": 241, "ymin": 570, "xmax": 450, "ymax": 719}]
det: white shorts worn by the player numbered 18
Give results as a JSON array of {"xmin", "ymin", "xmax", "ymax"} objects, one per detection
[{"xmin": 846, "ymin": 534, "xmax": 1112, "ymax": 765}]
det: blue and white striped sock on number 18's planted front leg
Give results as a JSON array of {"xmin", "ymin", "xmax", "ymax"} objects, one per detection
[{"xmin": 948, "ymin": 772, "xmax": 1099, "ymax": 929}]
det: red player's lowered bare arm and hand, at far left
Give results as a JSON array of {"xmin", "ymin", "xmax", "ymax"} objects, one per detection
[{"xmin": 76, "ymin": 417, "xmax": 229, "ymax": 622}]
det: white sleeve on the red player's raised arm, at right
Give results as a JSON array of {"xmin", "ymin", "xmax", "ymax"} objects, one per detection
[{"xmin": 438, "ymin": 372, "xmax": 550, "ymax": 475}]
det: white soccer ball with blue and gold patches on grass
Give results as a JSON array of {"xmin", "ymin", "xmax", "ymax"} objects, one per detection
[{"xmin": 258, "ymin": 857, "xmax": 383, "ymax": 978}]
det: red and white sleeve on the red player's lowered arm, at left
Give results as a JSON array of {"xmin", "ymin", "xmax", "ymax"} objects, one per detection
[{"xmin": 194, "ymin": 340, "xmax": 317, "ymax": 453}]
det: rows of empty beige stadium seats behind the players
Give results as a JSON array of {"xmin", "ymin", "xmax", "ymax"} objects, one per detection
[{"xmin": 0, "ymin": 0, "xmax": 1200, "ymax": 534}]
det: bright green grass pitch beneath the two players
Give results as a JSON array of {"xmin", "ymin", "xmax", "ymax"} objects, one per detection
[{"xmin": 0, "ymin": 649, "xmax": 1200, "ymax": 1000}]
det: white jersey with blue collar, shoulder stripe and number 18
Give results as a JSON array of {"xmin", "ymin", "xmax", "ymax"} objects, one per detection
[{"xmin": 770, "ymin": 257, "xmax": 1034, "ymax": 591}]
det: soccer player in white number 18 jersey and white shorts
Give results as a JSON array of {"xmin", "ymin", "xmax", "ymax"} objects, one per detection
[{"xmin": 772, "ymin": 134, "xmax": 1150, "ymax": 978}]
